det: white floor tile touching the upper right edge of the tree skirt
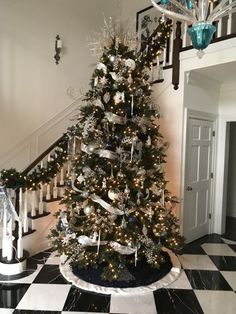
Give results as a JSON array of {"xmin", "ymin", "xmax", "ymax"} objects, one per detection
[{"xmin": 178, "ymin": 254, "xmax": 217, "ymax": 270}]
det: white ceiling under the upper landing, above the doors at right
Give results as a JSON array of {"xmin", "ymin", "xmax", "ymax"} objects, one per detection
[{"xmin": 194, "ymin": 62, "xmax": 236, "ymax": 84}]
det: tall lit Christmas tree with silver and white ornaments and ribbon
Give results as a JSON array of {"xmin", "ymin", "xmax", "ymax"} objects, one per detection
[{"xmin": 50, "ymin": 19, "xmax": 182, "ymax": 281}]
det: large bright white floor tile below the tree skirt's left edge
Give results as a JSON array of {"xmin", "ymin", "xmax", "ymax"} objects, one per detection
[{"xmin": 17, "ymin": 284, "xmax": 71, "ymax": 311}]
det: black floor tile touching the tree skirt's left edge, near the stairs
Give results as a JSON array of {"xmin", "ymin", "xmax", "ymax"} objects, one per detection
[{"xmin": 33, "ymin": 265, "xmax": 69, "ymax": 284}]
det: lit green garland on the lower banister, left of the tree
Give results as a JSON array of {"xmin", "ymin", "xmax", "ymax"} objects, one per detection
[{"xmin": 0, "ymin": 134, "xmax": 68, "ymax": 190}]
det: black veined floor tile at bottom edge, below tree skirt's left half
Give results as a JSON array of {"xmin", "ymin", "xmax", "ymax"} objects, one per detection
[{"xmin": 63, "ymin": 287, "xmax": 111, "ymax": 313}]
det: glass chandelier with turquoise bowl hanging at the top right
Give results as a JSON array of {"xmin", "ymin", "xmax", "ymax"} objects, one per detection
[{"xmin": 151, "ymin": 0, "xmax": 236, "ymax": 58}]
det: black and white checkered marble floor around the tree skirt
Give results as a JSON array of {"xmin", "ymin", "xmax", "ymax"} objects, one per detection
[{"xmin": 0, "ymin": 235, "xmax": 236, "ymax": 314}]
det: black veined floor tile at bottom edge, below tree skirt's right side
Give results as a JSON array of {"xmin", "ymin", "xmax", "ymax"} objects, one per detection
[{"xmin": 154, "ymin": 289, "xmax": 204, "ymax": 314}]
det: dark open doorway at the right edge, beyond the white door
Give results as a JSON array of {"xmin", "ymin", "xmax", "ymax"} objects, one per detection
[{"xmin": 224, "ymin": 122, "xmax": 236, "ymax": 241}]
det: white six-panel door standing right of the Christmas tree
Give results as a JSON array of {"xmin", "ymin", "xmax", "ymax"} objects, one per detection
[{"xmin": 183, "ymin": 117, "xmax": 214, "ymax": 242}]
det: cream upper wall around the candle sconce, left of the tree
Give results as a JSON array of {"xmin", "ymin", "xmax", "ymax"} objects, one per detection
[{"xmin": 0, "ymin": 0, "xmax": 119, "ymax": 166}]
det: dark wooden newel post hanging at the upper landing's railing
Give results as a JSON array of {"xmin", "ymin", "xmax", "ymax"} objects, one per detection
[{"xmin": 172, "ymin": 22, "xmax": 183, "ymax": 90}]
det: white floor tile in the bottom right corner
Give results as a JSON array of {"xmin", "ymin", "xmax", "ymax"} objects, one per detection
[{"xmin": 194, "ymin": 290, "xmax": 236, "ymax": 314}]
